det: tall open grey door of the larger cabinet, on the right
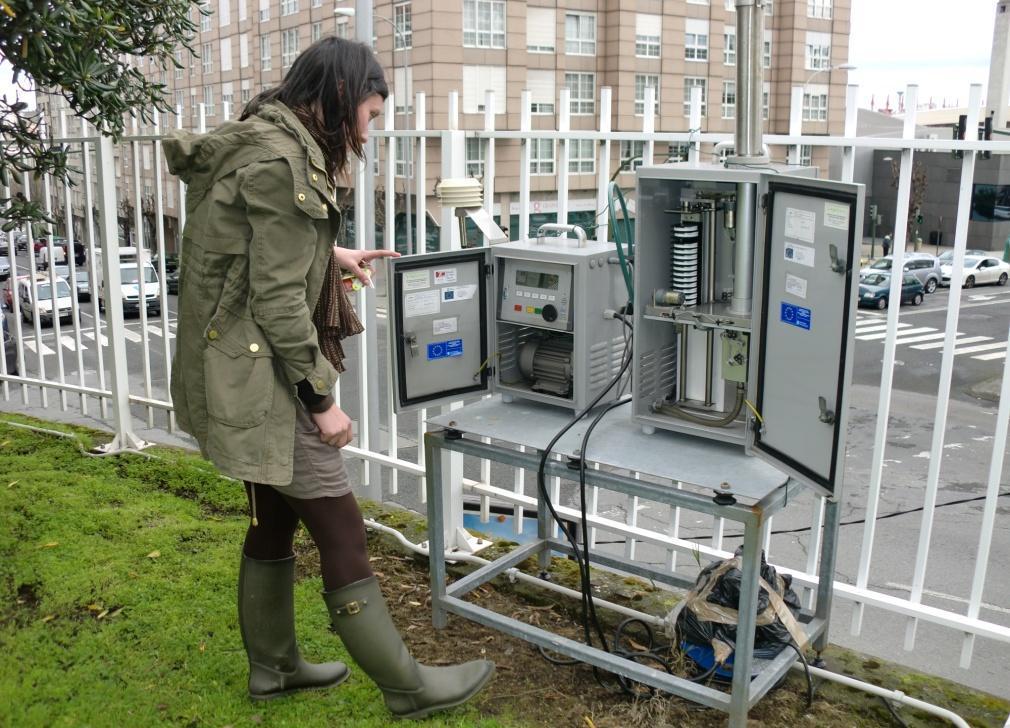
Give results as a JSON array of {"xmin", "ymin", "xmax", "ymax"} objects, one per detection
[{"xmin": 747, "ymin": 178, "xmax": 864, "ymax": 495}]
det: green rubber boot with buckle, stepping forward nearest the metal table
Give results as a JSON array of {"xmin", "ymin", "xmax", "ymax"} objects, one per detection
[{"xmin": 322, "ymin": 577, "xmax": 495, "ymax": 718}]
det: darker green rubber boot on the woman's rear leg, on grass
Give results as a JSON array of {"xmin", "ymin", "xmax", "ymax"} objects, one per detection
[{"xmin": 238, "ymin": 555, "xmax": 350, "ymax": 700}]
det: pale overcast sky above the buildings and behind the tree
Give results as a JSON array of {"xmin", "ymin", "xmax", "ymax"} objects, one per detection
[{"xmin": 0, "ymin": 0, "xmax": 997, "ymax": 113}]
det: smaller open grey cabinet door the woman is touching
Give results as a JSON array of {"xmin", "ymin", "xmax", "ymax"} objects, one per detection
[{"xmin": 387, "ymin": 248, "xmax": 493, "ymax": 413}]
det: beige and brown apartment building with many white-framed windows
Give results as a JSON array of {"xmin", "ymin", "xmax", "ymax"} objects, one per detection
[{"xmin": 35, "ymin": 0, "xmax": 850, "ymax": 250}]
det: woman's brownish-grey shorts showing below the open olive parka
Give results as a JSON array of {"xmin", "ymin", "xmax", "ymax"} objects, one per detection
[{"xmin": 274, "ymin": 403, "xmax": 351, "ymax": 499}]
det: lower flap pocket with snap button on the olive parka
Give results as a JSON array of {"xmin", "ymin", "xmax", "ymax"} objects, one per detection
[{"xmin": 203, "ymin": 320, "xmax": 276, "ymax": 428}]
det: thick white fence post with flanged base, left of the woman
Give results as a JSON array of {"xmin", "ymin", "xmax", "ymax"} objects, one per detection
[{"xmin": 95, "ymin": 135, "xmax": 150, "ymax": 452}]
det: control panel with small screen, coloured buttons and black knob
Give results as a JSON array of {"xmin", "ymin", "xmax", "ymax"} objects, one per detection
[{"xmin": 498, "ymin": 258, "xmax": 573, "ymax": 331}]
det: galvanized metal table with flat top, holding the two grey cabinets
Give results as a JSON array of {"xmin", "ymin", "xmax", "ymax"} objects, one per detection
[{"xmin": 424, "ymin": 398, "xmax": 837, "ymax": 728}]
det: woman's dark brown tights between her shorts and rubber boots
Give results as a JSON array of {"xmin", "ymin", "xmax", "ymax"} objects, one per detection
[{"xmin": 242, "ymin": 483, "xmax": 372, "ymax": 592}]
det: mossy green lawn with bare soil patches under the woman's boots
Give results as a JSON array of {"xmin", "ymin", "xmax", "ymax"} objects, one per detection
[{"xmin": 0, "ymin": 413, "xmax": 1010, "ymax": 728}]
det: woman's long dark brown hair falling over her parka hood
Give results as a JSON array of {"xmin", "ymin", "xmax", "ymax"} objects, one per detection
[{"xmin": 239, "ymin": 36, "xmax": 389, "ymax": 177}]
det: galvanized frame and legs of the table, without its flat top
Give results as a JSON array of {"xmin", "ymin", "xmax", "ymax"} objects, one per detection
[{"xmin": 424, "ymin": 423, "xmax": 837, "ymax": 728}]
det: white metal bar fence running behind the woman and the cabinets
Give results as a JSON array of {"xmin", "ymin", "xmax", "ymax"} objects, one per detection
[{"xmin": 0, "ymin": 86, "xmax": 1010, "ymax": 682}]
